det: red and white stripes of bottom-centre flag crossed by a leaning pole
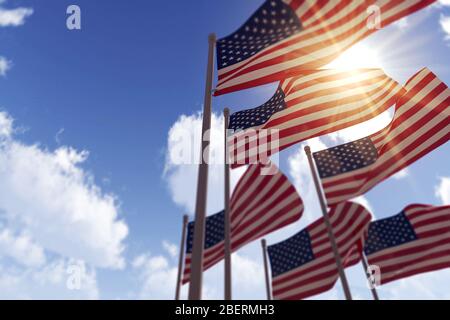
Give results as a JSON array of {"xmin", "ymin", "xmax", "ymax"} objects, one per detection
[{"xmin": 272, "ymin": 202, "xmax": 371, "ymax": 300}]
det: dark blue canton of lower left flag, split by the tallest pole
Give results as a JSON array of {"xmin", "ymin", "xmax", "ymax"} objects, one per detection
[{"xmin": 186, "ymin": 211, "xmax": 225, "ymax": 253}]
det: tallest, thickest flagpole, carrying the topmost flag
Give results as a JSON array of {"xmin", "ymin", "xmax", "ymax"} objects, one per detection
[{"xmin": 189, "ymin": 33, "xmax": 216, "ymax": 300}]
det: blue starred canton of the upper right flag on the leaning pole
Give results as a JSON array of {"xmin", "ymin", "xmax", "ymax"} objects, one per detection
[{"xmin": 313, "ymin": 138, "xmax": 378, "ymax": 179}]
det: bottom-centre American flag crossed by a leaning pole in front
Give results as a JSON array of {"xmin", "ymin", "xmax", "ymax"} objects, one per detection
[{"xmin": 268, "ymin": 202, "xmax": 371, "ymax": 300}]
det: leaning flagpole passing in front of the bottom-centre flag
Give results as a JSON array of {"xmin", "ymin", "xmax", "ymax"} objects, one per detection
[{"xmin": 305, "ymin": 146, "xmax": 352, "ymax": 300}]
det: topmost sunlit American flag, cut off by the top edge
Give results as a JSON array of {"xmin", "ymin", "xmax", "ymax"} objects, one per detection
[{"xmin": 215, "ymin": 0, "xmax": 435, "ymax": 95}]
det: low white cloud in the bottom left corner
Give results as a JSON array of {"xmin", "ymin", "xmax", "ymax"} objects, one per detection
[{"xmin": 0, "ymin": 259, "xmax": 99, "ymax": 300}]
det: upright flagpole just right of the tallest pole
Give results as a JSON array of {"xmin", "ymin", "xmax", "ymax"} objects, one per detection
[{"xmin": 223, "ymin": 108, "xmax": 232, "ymax": 300}]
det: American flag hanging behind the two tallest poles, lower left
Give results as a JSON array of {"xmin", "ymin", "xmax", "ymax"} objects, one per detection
[{"xmin": 183, "ymin": 164, "xmax": 303, "ymax": 283}]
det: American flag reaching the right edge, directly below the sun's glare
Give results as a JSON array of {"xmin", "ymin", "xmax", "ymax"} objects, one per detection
[{"xmin": 313, "ymin": 68, "xmax": 450, "ymax": 205}]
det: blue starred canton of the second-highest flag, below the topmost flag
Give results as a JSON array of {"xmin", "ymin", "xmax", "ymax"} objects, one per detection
[{"xmin": 228, "ymin": 87, "xmax": 286, "ymax": 132}]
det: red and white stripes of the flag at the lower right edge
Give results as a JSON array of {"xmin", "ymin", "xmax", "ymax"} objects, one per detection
[{"xmin": 367, "ymin": 204, "xmax": 450, "ymax": 284}]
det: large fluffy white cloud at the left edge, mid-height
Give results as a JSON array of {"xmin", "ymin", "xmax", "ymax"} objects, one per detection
[{"xmin": 0, "ymin": 112, "xmax": 128, "ymax": 268}]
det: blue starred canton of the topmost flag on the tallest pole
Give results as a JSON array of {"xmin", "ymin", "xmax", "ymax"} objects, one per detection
[{"xmin": 217, "ymin": 0, "xmax": 302, "ymax": 69}]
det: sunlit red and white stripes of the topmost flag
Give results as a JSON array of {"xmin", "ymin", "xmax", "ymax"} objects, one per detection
[{"xmin": 215, "ymin": 0, "xmax": 435, "ymax": 95}]
